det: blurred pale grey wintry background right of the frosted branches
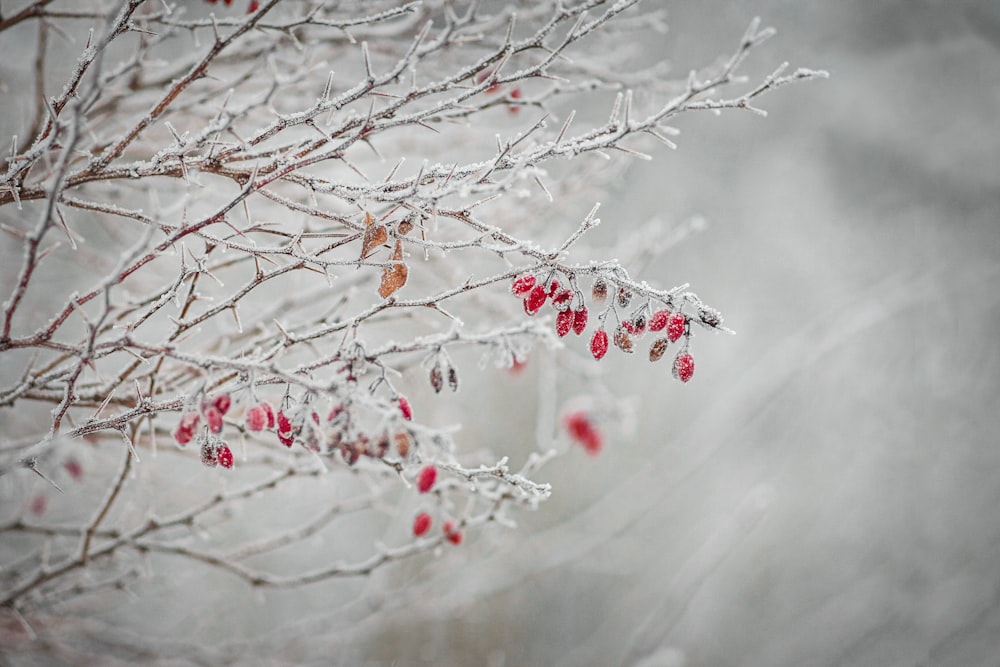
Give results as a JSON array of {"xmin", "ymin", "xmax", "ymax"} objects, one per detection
[{"xmin": 362, "ymin": 0, "xmax": 1000, "ymax": 667}]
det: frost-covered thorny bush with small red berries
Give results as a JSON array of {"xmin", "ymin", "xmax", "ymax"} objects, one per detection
[{"xmin": 0, "ymin": 0, "xmax": 821, "ymax": 636}]
